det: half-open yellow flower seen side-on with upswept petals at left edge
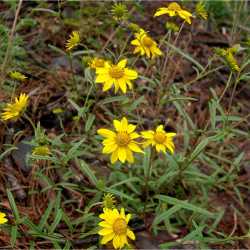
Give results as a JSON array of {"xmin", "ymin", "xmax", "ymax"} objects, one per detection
[{"xmin": 2, "ymin": 94, "xmax": 29, "ymax": 121}]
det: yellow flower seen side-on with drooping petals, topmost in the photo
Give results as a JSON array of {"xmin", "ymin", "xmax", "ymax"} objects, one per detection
[{"xmin": 154, "ymin": 2, "xmax": 192, "ymax": 24}]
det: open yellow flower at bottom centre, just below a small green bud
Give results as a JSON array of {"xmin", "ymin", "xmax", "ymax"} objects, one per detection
[{"xmin": 98, "ymin": 208, "xmax": 135, "ymax": 249}]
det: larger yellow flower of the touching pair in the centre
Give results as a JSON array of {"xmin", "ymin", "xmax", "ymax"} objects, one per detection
[{"xmin": 97, "ymin": 117, "xmax": 143, "ymax": 163}]
